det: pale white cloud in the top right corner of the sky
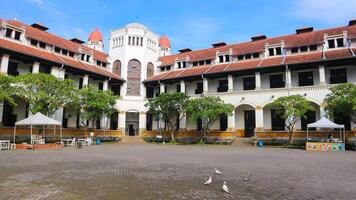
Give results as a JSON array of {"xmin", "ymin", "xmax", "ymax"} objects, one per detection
[{"xmin": 291, "ymin": 0, "xmax": 356, "ymax": 23}]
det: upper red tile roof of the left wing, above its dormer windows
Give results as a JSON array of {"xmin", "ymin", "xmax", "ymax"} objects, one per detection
[{"xmin": 0, "ymin": 18, "xmax": 108, "ymax": 63}]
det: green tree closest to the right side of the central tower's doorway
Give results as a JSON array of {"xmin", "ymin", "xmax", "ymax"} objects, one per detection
[{"xmin": 145, "ymin": 93, "xmax": 189, "ymax": 141}]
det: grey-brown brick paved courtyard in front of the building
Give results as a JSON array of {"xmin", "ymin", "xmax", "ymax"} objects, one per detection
[{"xmin": 0, "ymin": 144, "xmax": 356, "ymax": 199}]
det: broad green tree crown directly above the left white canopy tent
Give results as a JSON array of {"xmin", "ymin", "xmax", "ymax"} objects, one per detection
[{"xmin": 13, "ymin": 73, "xmax": 77, "ymax": 117}]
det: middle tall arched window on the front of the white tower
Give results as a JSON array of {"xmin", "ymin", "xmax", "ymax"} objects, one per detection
[{"xmin": 126, "ymin": 59, "xmax": 141, "ymax": 96}]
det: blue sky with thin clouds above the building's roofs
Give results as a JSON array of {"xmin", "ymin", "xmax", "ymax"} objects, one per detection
[{"xmin": 0, "ymin": 0, "xmax": 356, "ymax": 52}]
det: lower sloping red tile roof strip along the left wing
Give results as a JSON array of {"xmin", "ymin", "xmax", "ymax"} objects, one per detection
[{"xmin": 0, "ymin": 38, "xmax": 123, "ymax": 80}]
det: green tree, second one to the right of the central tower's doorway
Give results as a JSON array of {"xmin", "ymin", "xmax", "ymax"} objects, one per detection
[{"xmin": 185, "ymin": 97, "xmax": 234, "ymax": 139}]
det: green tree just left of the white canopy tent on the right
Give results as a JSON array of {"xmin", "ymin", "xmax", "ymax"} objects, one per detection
[{"xmin": 266, "ymin": 95, "xmax": 314, "ymax": 145}]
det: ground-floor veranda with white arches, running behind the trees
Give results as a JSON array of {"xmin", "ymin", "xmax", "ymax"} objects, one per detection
[{"xmin": 0, "ymin": 101, "xmax": 356, "ymax": 139}]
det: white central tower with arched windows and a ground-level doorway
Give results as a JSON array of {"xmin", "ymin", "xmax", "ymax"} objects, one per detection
[{"xmin": 109, "ymin": 23, "xmax": 167, "ymax": 136}]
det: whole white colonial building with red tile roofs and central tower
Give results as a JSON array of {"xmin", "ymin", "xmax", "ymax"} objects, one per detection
[{"xmin": 0, "ymin": 20, "xmax": 356, "ymax": 140}]
